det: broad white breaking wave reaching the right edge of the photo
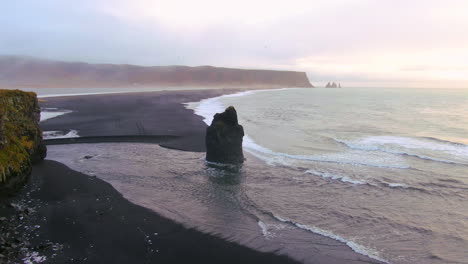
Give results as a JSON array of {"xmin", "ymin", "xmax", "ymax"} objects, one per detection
[{"xmin": 334, "ymin": 136, "xmax": 468, "ymax": 165}]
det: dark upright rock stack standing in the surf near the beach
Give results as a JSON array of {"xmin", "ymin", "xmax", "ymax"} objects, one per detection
[{"xmin": 206, "ymin": 106, "xmax": 244, "ymax": 164}]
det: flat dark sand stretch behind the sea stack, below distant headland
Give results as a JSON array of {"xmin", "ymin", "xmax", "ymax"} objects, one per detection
[{"xmin": 41, "ymin": 89, "xmax": 237, "ymax": 151}]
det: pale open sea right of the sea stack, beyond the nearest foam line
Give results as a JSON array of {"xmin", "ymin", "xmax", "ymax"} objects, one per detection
[{"xmin": 188, "ymin": 88, "xmax": 468, "ymax": 263}]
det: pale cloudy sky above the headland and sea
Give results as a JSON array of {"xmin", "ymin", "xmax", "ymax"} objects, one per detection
[{"xmin": 0, "ymin": 0, "xmax": 468, "ymax": 88}]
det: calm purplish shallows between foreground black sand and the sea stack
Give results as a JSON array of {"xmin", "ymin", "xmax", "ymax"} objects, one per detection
[{"xmin": 48, "ymin": 143, "xmax": 386, "ymax": 263}]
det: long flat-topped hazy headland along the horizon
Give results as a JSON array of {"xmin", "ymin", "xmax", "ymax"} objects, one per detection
[{"xmin": 0, "ymin": 56, "xmax": 313, "ymax": 88}]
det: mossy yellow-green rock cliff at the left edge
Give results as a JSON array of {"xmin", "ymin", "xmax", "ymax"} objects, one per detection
[{"xmin": 0, "ymin": 90, "xmax": 47, "ymax": 195}]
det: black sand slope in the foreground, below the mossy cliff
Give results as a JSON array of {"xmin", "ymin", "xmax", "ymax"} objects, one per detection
[{"xmin": 7, "ymin": 160, "xmax": 296, "ymax": 264}]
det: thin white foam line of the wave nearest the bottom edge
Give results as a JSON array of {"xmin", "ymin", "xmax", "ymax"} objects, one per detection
[{"xmin": 273, "ymin": 215, "xmax": 390, "ymax": 263}]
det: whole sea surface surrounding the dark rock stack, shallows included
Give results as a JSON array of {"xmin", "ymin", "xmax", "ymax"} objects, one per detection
[{"xmin": 44, "ymin": 88, "xmax": 468, "ymax": 263}]
